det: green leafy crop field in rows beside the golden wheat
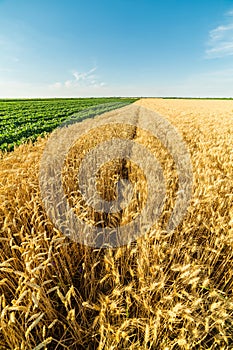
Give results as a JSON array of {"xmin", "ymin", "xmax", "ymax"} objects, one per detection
[{"xmin": 0, "ymin": 98, "xmax": 136, "ymax": 151}]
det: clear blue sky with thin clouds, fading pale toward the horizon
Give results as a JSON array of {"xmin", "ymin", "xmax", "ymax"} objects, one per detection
[{"xmin": 0, "ymin": 0, "xmax": 233, "ymax": 98}]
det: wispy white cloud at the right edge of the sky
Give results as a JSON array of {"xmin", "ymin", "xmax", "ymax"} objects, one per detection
[{"xmin": 205, "ymin": 10, "xmax": 233, "ymax": 59}]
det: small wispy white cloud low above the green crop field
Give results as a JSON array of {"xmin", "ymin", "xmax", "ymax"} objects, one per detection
[{"xmin": 50, "ymin": 67, "xmax": 106, "ymax": 89}]
